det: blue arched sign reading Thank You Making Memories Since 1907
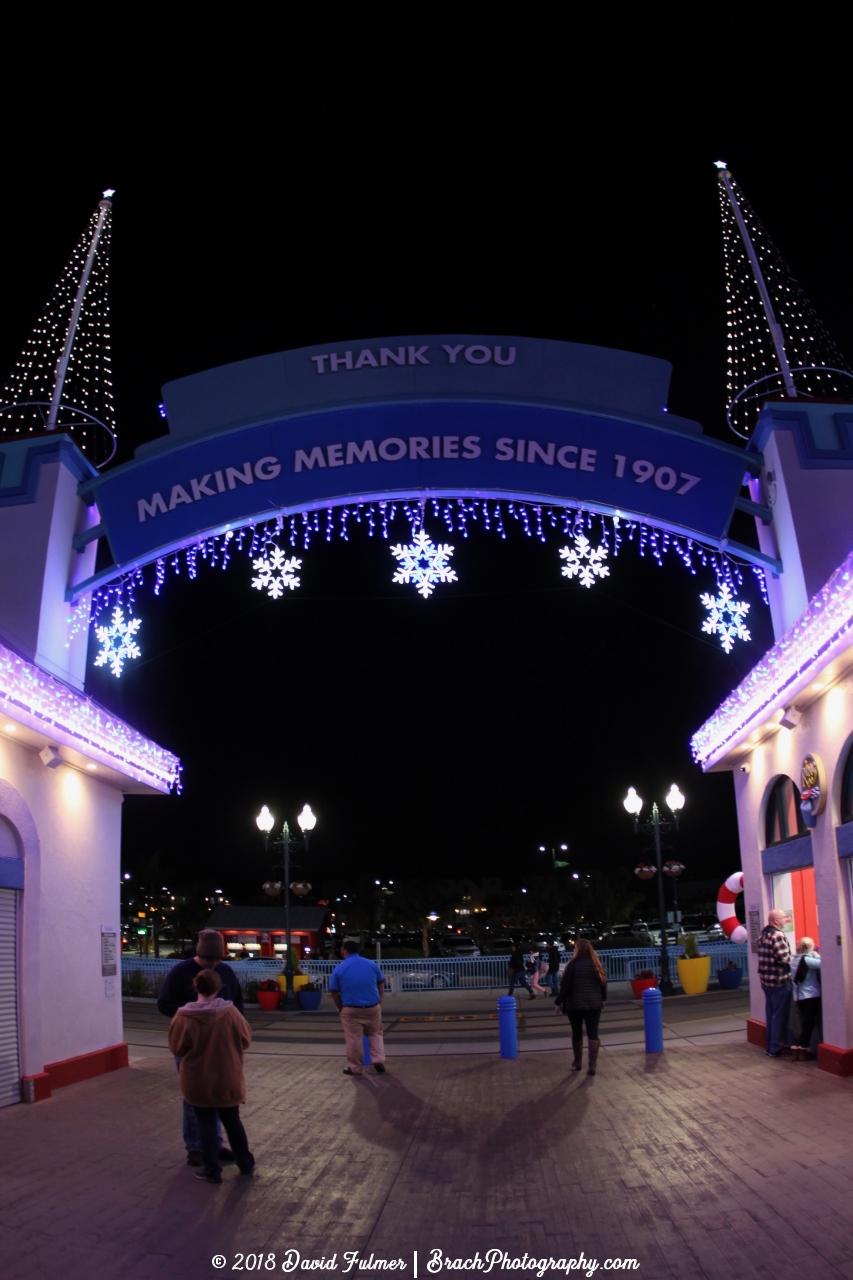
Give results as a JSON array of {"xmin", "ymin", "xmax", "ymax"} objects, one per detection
[{"xmin": 68, "ymin": 334, "xmax": 780, "ymax": 614}]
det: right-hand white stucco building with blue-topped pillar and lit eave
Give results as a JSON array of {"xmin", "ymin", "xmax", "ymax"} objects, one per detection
[{"xmin": 693, "ymin": 401, "xmax": 853, "ymax": 1075}]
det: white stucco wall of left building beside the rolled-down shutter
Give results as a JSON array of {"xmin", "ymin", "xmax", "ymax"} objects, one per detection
[{"xmin": 0, "ymin": 724, "xmax": 123, "ymax": 1075}]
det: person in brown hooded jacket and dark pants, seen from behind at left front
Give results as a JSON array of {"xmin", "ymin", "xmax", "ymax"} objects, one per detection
[{"xmin": 169, "ymin": 969, "xmax": 255, "ymax": 1183}]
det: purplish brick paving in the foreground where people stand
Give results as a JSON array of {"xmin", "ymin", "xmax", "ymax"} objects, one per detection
[{"xmin": 0, "ymin": 998, "xmax": 853, "ymax": 1280}]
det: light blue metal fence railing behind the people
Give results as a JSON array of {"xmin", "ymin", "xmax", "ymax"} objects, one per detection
[{"xmin": 122, "ymin": 942, "xmax": 747, "ymax": 996}]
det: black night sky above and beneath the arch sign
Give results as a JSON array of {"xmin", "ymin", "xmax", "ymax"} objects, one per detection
[{"xmin": 0, "ymin": 22, "xmax": 853, "ymax": 901}]
